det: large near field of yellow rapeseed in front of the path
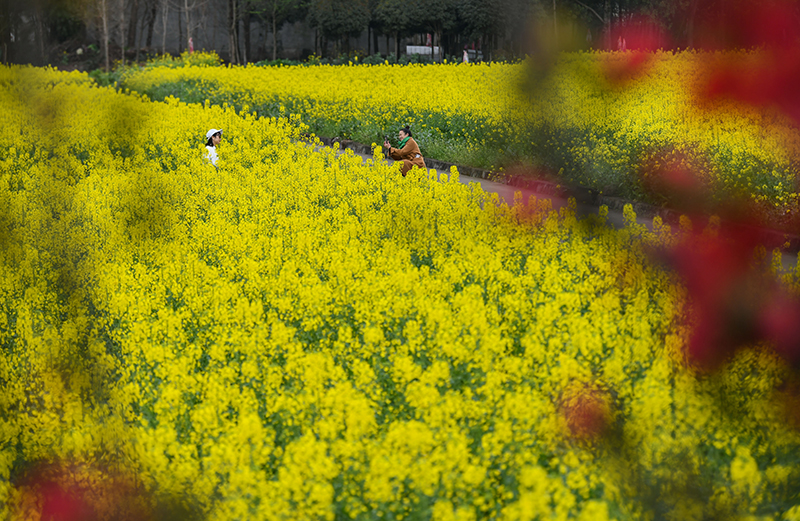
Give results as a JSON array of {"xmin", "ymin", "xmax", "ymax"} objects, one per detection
[{"xmin": 0, "ymin": 67, "xmax": 800, "ymax": 520}]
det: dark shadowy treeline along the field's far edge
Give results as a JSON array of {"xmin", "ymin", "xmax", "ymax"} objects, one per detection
[{"xmin": 0, "ymin": 0, "xmax": 800, "ymax": 68}]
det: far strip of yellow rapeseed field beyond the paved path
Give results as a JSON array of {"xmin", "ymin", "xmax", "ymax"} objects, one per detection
[{"xmin": 122, "ymin": 51, "xmax": 800, "ymax": 218}]
